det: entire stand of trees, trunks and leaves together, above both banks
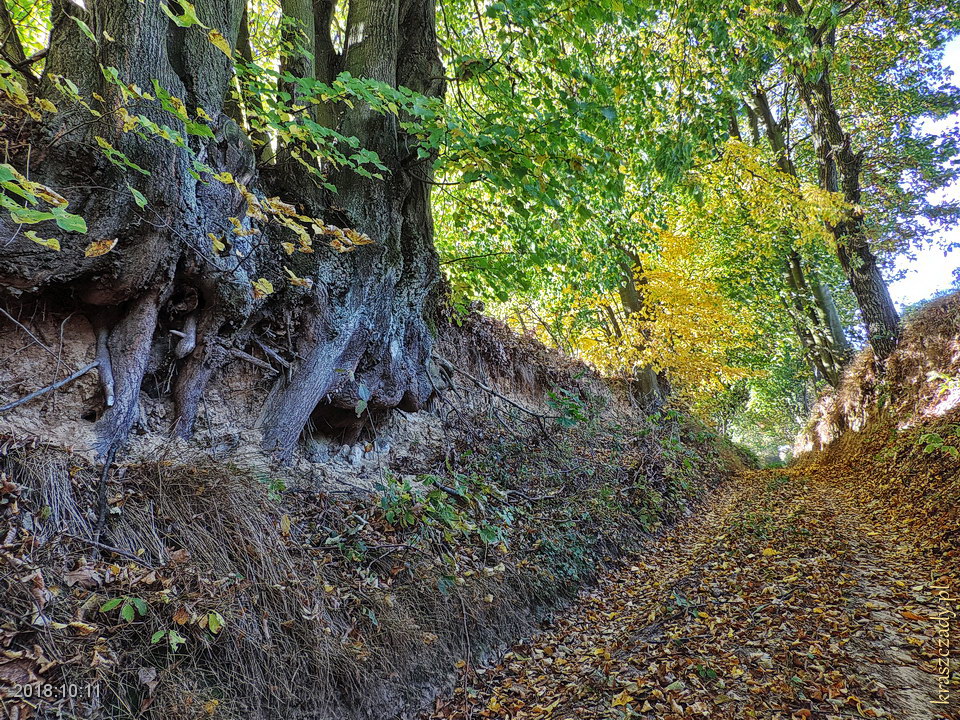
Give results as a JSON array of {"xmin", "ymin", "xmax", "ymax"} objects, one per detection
[{"xmin": 0, "ymin": 0, "xmax": 960, "ymax": 457}]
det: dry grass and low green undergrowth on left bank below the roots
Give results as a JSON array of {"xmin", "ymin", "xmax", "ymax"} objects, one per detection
[{"xmin": 0, "ymin": 398, "xmax": 742, "ymax": 718}]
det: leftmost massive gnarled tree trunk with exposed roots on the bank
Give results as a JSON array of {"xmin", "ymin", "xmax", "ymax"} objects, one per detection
[{"xmin": 0, "ymin": 0, "xmax": 252, "ymax": 453}]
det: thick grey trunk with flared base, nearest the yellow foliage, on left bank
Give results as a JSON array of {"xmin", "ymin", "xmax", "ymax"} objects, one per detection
[{"xmin": 263, "ymin": 0, "xmax": 444, "ymax": 457}]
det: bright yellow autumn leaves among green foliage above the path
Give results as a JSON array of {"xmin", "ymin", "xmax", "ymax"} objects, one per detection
[{"xmin": 502, "ymin": 140, "xmax": 854, "ymax": 405}]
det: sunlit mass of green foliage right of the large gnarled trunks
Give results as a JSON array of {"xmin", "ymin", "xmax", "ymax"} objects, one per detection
[{"xmin": 437, "ymin": 0, "xmax": 960, "ymax": 444}]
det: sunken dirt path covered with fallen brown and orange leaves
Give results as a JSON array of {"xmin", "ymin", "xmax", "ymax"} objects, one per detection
[{"xmin": 432, "ymin": 471, "xmax": 960, "ymax": 720}]
